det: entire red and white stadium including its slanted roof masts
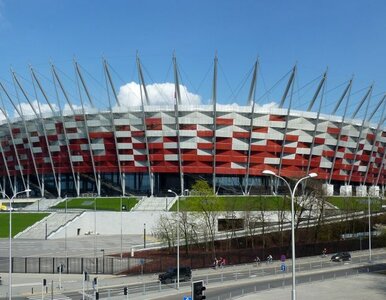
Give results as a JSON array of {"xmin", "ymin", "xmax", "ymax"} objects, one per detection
[{"xmin": 0, "ymin": 58, "xmax": 386, "ymax": 197}]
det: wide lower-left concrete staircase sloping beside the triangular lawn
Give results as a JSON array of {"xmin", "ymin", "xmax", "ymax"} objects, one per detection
[{"xmin": 15, "ymin": 211, "xmax": 83, "ymax": 239}]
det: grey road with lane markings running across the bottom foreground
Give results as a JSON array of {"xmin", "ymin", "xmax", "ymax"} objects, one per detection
[{"xmin": 0, "ymin": 249, "xmax": 386, "ymax": 300}]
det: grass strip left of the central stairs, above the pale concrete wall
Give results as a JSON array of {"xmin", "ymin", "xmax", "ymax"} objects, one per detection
[{"xmin": 54, "ymin": 197, "xmax": 138, "ymax": 211}]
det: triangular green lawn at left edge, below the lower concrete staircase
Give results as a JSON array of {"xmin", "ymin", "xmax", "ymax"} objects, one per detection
[{"xmin": 0, "ymin": 212, "xmax": 49, "ymax": 238}]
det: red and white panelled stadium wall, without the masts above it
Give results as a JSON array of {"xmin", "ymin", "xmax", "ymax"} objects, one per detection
[{"xmin": 0, "ymin": 104, "xmax": 386, "ymax": 194}]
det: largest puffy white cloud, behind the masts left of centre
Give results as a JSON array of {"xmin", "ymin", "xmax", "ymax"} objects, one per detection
[{"xmin": 118, "ymin": 82, "xmax": 201, "ymax": 107}]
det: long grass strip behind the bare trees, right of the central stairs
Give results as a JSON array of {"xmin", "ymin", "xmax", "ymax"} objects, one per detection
[{"xmin": 170, "ymin": 196, "xmax": 291, "ymax": 211}]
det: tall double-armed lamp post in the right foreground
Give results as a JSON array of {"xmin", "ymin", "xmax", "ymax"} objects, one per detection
[{"xmin": 263, "ymin": 170, "xmax": 318, "ymax": 300}]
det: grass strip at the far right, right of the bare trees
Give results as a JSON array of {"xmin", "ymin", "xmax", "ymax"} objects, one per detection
[{"xmin": 327, "ymin": 197, "xmax": 384, "ymax": 212}]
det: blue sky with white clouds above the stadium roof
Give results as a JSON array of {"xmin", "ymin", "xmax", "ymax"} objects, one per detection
[{"xmin": 0, "ymin": 0, "xmax": 386, "ymax": 117}]
